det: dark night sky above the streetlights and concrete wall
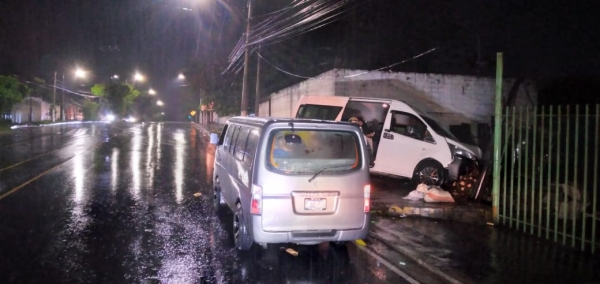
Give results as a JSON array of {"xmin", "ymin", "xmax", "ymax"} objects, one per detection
[{"xmin": 0, "ymin": 0, "xmax": 600, "ymax": 117}]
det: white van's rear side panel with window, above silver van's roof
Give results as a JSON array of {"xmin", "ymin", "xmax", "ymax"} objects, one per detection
[{"xmin": 294, "ymin": 95, "xmax": 350, "ymax": 121}]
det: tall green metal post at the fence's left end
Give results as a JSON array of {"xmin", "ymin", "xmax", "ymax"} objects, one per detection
[{"xmin": 492, "ymin": 52, "xmax": 503, "ymax": 224}]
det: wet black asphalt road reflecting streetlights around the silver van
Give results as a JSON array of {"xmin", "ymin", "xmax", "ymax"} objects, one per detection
[{"xmin": 0, "ymin": 123, "xmax": 407, "ymax": 283}]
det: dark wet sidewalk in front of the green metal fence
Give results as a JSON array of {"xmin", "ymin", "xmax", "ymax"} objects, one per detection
[{"xmin": 371, "ymin": 217, "xmax": 600, "ymax": 283}]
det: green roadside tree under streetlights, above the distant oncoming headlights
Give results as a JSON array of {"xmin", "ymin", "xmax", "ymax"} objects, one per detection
[{"xmin": 92, "ymin": 83, "xmax": 140, "ymax": 117}]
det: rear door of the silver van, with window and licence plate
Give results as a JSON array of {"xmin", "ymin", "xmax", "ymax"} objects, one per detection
[{"xmin": 259, "ymin": 125, "xmax": 369, "ymax": 231}]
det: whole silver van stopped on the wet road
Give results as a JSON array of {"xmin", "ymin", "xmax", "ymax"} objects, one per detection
[{"xmin": 211, "ymin": 117, "xmax": 371, "ymax": 250}]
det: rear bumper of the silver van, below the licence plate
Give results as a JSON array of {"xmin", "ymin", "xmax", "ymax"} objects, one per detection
[{"xmin": 252, "ymin": 213, "xmax": 371, "ymax": 245}]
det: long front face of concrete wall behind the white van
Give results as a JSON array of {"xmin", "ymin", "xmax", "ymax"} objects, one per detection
[{"xmin": 335, "ymin": 70, "xmax": 537, "ymax": 125}]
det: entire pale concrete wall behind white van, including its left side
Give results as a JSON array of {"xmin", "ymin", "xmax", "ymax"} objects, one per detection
[{"xmin": 254, "ymin": 69, "xmax": 537, "ymax": 124}]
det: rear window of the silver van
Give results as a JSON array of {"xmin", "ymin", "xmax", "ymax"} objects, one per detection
[{"xmin": 267, "ymin": 130, "xmax": 362, "ymax": 175}]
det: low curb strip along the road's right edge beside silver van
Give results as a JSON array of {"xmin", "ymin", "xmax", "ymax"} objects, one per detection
[{"xmin": 370, "ymin": 223, "xmax": 474, "ymax": 284}]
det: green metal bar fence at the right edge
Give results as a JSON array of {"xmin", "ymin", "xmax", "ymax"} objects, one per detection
[{"xmin": 498, "ymin": 105, "xmax": 600, "ymax": 253}]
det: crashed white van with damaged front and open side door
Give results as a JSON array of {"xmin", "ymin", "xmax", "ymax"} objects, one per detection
[{"xmin": 294, "ymin": 95, "xmax": 481, "ymax": 185}]
